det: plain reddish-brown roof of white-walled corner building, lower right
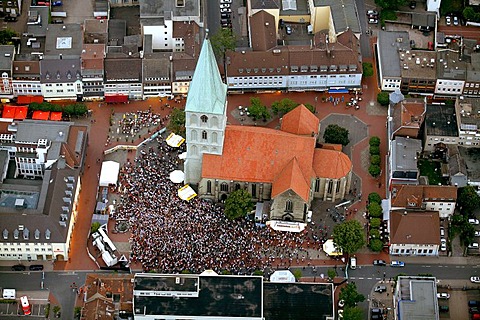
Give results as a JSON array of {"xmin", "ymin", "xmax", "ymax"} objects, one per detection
[{"xmin": 390, "ymin": 210, "xmax": 440, "ymax": 244}]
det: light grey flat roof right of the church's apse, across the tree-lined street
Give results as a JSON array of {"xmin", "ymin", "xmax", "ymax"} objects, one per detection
[{"xmin": 392, "ymin": 137, "xmax": 422, "ymax": 171}]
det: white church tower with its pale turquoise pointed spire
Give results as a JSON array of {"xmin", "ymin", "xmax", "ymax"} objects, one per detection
[{"xmin": 185, "ymin": 38, "xmax": 227, "ymax": 184}]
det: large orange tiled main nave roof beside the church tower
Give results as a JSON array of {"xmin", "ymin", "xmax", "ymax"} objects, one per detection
[{"xmin": 202, "ymin": 125, "xmax": 315, "ymax": 183}]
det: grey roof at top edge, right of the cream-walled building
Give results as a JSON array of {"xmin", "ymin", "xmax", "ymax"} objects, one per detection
[{"xmin": 316, "ymin": 0, "xmax": 361, "ymax": 33}]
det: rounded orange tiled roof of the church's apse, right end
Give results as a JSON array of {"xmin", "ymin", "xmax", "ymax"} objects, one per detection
[{"xmin": 313, "ymin": 148, "xmax": 352, "ymax": 179}]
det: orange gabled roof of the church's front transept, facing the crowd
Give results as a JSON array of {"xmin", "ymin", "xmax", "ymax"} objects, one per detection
[{"xmin": 272, "ymin": 158, "xmax": 310, "ymax": 202}]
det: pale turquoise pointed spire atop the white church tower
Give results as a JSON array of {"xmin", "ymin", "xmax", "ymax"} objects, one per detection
[{"xmin": 185, "ymin": 37, "xmax": 227, "ymax": 115}]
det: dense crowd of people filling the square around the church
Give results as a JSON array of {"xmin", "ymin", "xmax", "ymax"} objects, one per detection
[{"xmin": 114, "ymin": 136, "xmax": 329, "ymax": 274}]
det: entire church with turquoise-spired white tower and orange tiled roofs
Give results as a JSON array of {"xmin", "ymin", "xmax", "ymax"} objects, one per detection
[{"xmin": 185, "ymin": 39, "xmax": 352, "ymax": 223}]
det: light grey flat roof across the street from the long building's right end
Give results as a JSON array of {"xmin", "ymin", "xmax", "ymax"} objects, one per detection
[{"xmin": 377, "ymin": 31, "xmax": 410, "ymax": 78}]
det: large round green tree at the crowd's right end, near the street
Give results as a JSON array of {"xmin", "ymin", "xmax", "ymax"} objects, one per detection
[{"xmin": 333, "ymin": 220, "xmax": 365, "ymax": 255}]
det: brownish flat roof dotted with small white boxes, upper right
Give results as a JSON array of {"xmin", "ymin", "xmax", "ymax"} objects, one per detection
[{"xmin": 399, "ymin": 50, "xmax": 437, "ymax": 79}]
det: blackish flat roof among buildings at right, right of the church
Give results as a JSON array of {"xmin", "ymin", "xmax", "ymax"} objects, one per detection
[{"xmin": 425, "ymin": 104, "xmax": 458, "ymax": 137}]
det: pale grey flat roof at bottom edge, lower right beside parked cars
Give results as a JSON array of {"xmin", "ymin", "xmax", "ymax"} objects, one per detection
[{"xmin": 397, "ymin": 276, "xmax": 439, "ymax": 320}]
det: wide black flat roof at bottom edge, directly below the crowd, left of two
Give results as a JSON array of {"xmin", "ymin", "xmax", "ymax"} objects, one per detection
[{"xmin": 133, "ymin": 274, "xmax": 263, "ymax": 319}]
